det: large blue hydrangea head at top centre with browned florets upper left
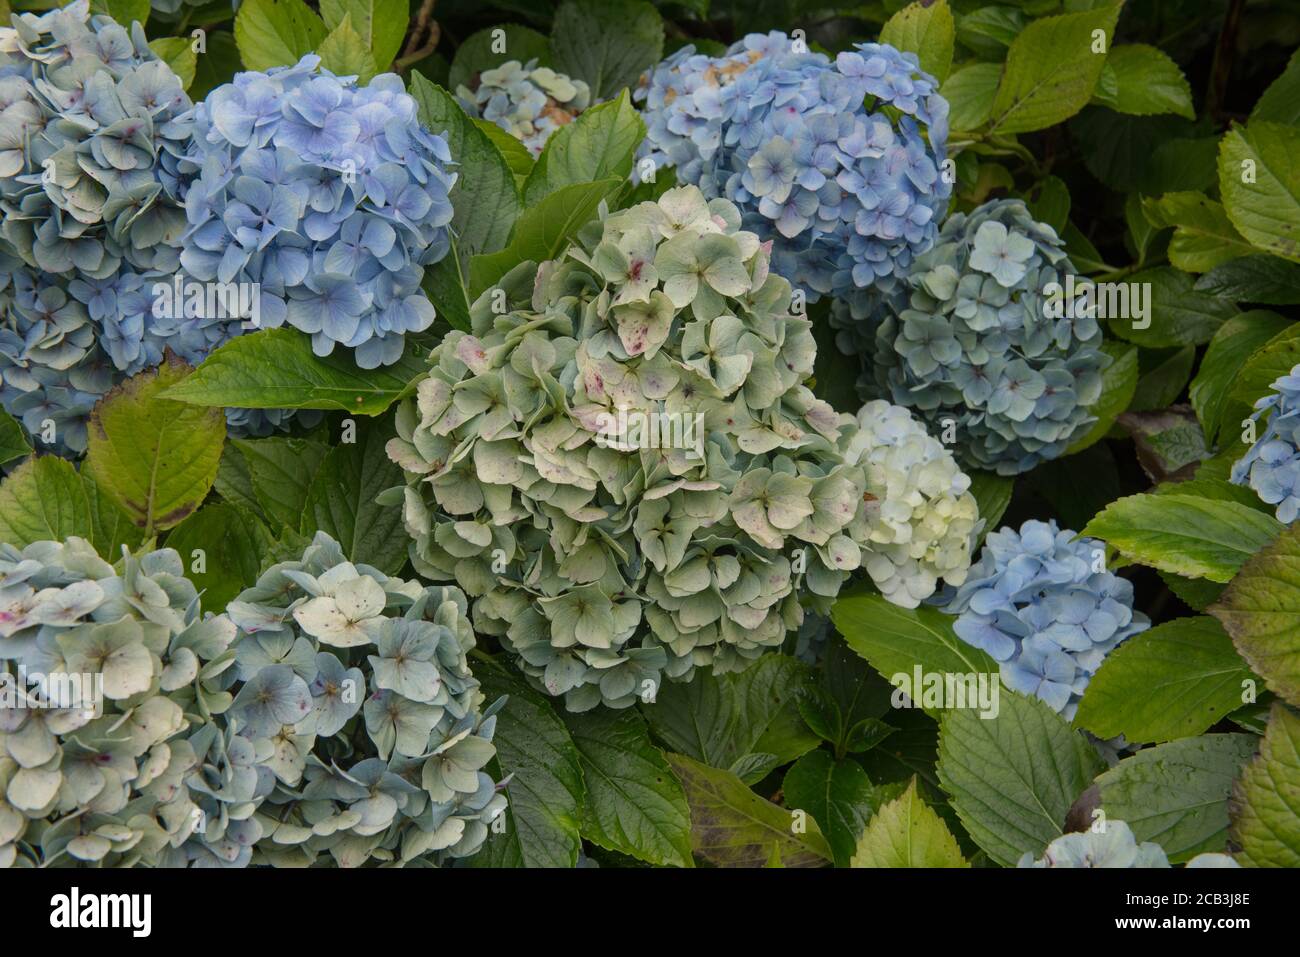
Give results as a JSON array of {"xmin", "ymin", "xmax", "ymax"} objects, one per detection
[{"xmin": 646, "ymin": 34, "xmax": 952, "ymax": 312}]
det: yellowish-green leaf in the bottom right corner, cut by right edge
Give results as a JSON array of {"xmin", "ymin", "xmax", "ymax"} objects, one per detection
[{"xmin": 1229, "ymin": 702, "xmax": 1300, "ymax": 867}]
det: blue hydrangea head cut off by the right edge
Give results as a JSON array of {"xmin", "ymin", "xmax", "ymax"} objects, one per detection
[{"xmin": 1232, "ymin": 365, "xmax": 1300, "ymax": 525}]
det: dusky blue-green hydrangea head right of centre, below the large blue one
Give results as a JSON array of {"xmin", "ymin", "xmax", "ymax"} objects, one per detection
[{"xmin": 874, "ymin": 199, "xmax": 1110, "ymax": 475}]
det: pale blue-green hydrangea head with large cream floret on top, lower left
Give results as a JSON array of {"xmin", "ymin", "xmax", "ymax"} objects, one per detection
[{"xmin": 218, "ymin": 532, "xmax": 506, "ymax": 866}]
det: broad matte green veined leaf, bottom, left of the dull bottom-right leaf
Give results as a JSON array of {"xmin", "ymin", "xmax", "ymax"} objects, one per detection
[{"xmin": 939, "ymin": 689, "xmax": 1105, "ymax": 866}]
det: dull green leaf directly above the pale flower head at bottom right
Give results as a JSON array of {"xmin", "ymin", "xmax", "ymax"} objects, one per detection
[{"xmin": 1097, "ymin": 735, "xmax": 1257, "ymax": 863}]
